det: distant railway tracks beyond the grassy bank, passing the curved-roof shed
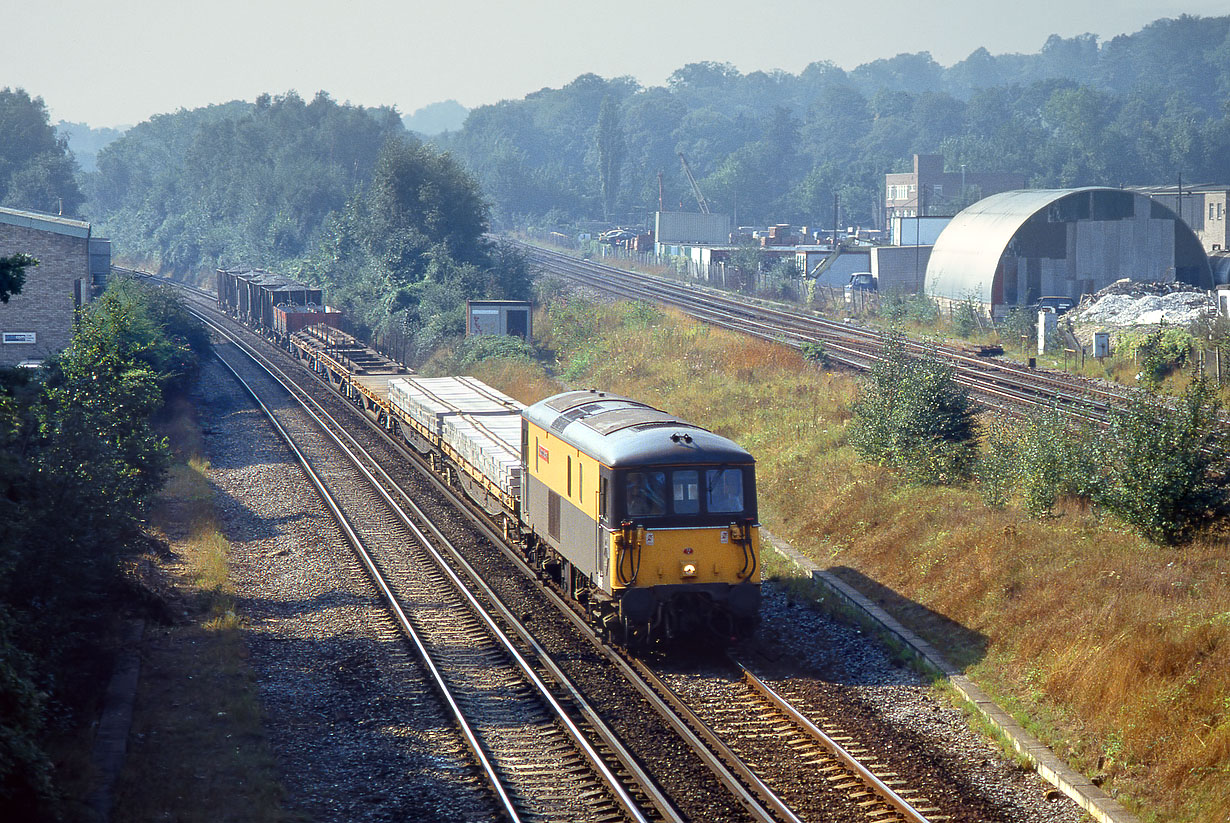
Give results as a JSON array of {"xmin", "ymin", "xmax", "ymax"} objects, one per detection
[{"xmin": 519, "ymin": 238, "xmax": 1125, "ymax": 422}]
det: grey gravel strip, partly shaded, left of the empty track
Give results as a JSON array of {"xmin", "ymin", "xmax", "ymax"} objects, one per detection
[{"xmin": 198, "ymin": 363, "xmax": 497, "ymax": 821}]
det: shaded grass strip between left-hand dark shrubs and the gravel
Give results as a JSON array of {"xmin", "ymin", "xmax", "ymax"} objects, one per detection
[{"xmin": 113, "ymin": 393, "xmax": 289, "ymax": 822}]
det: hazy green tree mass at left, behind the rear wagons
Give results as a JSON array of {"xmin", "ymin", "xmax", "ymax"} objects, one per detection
[{"xmin": 0, "ymin": 90, "xmax": 529, "ymax": 358}]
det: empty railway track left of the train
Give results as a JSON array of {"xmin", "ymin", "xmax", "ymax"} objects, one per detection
[{"xmin": 201, "ymin": 326, "xmax": 681, "ymax": 821}]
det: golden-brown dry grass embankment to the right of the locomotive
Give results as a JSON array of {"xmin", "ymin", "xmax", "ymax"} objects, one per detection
[{"xmin": 469, "ymin": 298, "xmax": 1230, "ymax": 823}]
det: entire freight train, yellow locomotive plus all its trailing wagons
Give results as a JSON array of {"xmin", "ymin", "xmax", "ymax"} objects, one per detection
[{"xmin": 219, "ymin": 266, "xmax": 760, "ymax": 648}]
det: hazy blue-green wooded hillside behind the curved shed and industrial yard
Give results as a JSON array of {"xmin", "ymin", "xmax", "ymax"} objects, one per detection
[{"xmin": 437, "ymin": 16, "xmax": 1230, "ymax": 225}]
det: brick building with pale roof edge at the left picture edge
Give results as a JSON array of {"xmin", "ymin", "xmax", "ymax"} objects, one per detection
[{"xmin": 0, "ymin": 208, "xmax": 111, "ymax": 365}]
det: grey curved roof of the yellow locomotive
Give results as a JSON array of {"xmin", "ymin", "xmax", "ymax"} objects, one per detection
[{"xmin": 522, "ymin": 389, "xmax": 754, "ymax": 467}]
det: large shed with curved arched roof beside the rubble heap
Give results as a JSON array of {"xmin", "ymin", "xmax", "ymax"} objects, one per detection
[{"xmin": 925, "ymin": 187, "xmax": 1213, "ymax": 312}]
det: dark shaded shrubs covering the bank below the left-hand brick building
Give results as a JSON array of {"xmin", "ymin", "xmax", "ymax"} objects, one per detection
[{"xmin": 0, "ymin": 283, "xmax": 208, "ymax": 819}]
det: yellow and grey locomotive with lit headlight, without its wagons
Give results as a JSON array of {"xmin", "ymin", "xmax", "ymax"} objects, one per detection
[{"xmin": 520, "ymin": 390, "xmax": 760, "ymax": 646}]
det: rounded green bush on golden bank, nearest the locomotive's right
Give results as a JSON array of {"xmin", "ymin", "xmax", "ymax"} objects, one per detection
[{"xmin": 850, "ymin": 333, "xmax": 977, "ymax": 483}]
